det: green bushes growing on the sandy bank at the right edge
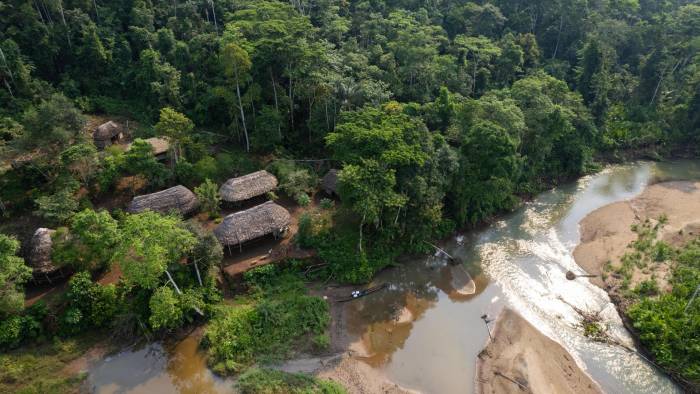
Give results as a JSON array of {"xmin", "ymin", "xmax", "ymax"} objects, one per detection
[{"xmin": 606, "ymin": 220, "xmax": 700, "ymax": 387}]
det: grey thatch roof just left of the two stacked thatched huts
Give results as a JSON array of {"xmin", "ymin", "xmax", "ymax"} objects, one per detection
[{"xmin": 127, "ymin": 185, "xmax": 198, "ymax": 215}]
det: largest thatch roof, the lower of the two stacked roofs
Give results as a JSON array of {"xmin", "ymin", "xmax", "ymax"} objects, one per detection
[{"xmin": 214, "ymin": 201, "xmax": 291, "ymax": 246}]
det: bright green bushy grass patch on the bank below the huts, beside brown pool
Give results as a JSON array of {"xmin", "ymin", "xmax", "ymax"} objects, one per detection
[{"xmin": 203, "ymin": 265, "xmax": 330, "ymax": 375}]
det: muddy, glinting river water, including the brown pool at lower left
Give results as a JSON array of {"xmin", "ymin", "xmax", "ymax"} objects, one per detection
[{"xmin": 88, "ymin": 161, "xmax": 700, "ymax": 394}]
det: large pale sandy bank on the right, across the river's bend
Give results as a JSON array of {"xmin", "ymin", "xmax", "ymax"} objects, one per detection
[{"xmin": 574, "ymin": 181, "xmax": 700, "ymax": 299}]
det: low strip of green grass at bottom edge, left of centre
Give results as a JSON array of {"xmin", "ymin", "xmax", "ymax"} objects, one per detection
[{"xmin": 236, "ymin": 368, "xmax": 346, "ymax": 394}]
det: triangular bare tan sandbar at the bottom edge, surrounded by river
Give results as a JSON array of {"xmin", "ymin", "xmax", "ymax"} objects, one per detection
[{"xmin": 476, "ymin": 308, "xmax": 602, "ymax": 394}]
